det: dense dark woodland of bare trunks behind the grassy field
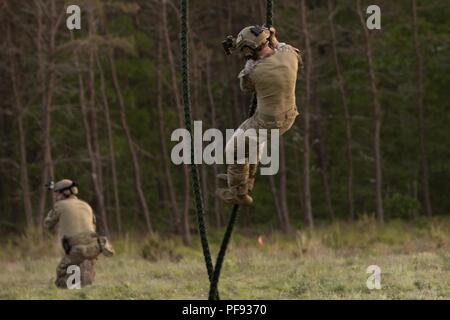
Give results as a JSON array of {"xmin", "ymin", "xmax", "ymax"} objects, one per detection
[{"xmin": 0, "ymin": 0, "xmax": 450, "ymax": 244}]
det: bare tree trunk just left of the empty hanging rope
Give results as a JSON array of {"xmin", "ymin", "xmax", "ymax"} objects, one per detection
[{"xmin": 162, "ymin": 0, "xmax": 192, "ymax": 245}]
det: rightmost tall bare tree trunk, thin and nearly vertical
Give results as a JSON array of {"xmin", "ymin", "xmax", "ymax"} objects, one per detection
[{"xmin": 411, "ymin": 0, "xmax": 433, "ymax": 217}]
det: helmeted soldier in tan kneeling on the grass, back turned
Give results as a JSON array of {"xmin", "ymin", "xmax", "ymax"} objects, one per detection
[{"xmin": 44, "ymin": 179, "xmax": 114, "ymax": 288}]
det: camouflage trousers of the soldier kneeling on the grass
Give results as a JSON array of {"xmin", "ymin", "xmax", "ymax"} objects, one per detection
[{"xmin": 55, "ymin": 232, "xmax": 102, "ymax": 289}]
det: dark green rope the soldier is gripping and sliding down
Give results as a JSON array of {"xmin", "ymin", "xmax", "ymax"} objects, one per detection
[{"xmin": 209, "ymin": 0, "xmax": 273, "ymax": 300}]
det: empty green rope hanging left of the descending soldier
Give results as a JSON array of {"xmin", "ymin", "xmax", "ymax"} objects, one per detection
[{"xmin": 180, "ymin": 0, "xmax": 219, "ymax": 299}]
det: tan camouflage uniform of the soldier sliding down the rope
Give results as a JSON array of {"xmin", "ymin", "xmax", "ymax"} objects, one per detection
[{"xmin": 218, "ymin": 43, "xmax": 302, "ymax": 203}]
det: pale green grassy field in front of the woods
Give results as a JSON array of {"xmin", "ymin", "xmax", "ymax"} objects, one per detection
[{"xmin": 0, "ymin": 219, "xmax": 450, "ymax": 299}]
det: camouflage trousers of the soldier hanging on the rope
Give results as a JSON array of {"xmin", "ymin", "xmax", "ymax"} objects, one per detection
[{"xmin": 225, "ymin": 108, "xmax": 299, "ymax": 196}]
